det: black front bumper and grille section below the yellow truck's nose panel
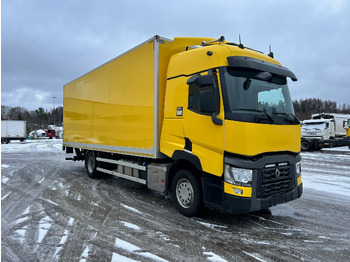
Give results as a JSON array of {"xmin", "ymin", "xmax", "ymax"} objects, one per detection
[{"xmin": 222, "ymin": 153, "xmax": 303, "ymax": 214}]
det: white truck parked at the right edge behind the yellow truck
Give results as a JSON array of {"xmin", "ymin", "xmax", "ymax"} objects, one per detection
[{"xmin": 301, "ymin": 113, "xmax": 350, "ymax": 151}]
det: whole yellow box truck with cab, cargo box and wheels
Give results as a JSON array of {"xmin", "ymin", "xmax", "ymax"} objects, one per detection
[{"xmin": 63, "ymin": 36, "xmax": 302, "ymax": 216}]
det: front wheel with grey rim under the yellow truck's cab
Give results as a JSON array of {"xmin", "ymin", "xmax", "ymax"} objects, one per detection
[{"xmin": 172, "ymin": 170, "xmax": 202, "ymax": 217}]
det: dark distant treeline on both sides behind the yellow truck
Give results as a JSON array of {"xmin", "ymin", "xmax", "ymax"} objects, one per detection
[{"xmin": 1, "ymin": 98, "xmax": 350, "ymax": 132}]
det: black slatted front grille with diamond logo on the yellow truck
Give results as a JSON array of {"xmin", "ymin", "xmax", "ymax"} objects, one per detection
[{"xmin": 257, "ymin": 164, "xmax": 292, "ymax": 198}]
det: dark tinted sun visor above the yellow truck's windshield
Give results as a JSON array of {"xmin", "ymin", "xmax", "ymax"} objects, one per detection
[{"xmin": 227, "ymin": 56, "xmax": 298, "ymax": 81}]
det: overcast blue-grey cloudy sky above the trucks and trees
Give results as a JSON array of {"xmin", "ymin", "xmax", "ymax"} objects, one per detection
[{"xmin": 1, "ymin": 0, "xmax": 350, "ymax": 110}]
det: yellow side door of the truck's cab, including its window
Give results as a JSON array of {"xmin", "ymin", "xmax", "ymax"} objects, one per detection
[{"xmin": 184, "ymin": 72, "xmax": 224, "ymax": 176}]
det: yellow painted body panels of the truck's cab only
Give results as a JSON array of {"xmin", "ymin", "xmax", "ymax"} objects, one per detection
[{"xmin": 161, "ymin": 38, "xmax": 300, "ymax": 176}]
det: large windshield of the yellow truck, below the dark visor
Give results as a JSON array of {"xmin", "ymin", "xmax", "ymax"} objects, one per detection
[{"xmin": 224, "ymin": 68, "xmax": 299, "ymax": 124}]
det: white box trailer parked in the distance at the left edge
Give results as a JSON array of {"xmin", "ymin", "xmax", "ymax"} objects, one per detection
[{"xmin": 1, "ymin": 120, "xmax": 27, "ymax": 144}]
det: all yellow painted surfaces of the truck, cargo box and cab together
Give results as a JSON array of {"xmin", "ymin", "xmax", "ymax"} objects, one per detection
[{"xmin": 64, "ymin": 35, "xmax": 300, "ymax": 182}]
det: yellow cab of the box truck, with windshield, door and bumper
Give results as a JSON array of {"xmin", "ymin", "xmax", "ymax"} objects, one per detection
[{"xmin": 160, "ymin": 39, "xmax": 302, "ymax": 213}]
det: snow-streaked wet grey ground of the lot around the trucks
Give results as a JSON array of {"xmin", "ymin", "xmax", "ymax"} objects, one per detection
[{"xmin": 1, "ymin": 140, "xmax": 350, "ymax": 261}]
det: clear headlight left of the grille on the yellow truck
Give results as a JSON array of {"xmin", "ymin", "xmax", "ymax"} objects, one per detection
[{"xmin": 224, "ymin": 165, "xmax": 253, "ymax": 186}]
